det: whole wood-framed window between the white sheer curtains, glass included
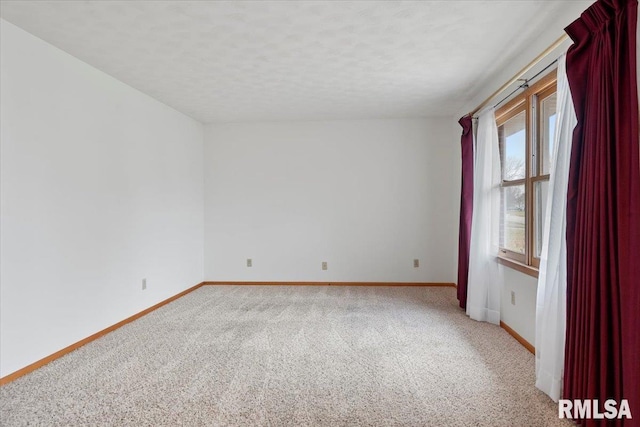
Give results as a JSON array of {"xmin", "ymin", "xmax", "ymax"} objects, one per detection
[{"xmin": 496, "ymin": 73, "xmax": 556, "ymax": 276}]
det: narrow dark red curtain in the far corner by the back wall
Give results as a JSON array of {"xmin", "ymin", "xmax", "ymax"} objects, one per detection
[{"xmin": 458, "ymin": 116, "xmax": 473, "ymax": 309}]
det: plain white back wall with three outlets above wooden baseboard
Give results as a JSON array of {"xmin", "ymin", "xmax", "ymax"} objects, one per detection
[{"xmin": 205, "ymin": 119, "xmax": 460, "ymax": 282}]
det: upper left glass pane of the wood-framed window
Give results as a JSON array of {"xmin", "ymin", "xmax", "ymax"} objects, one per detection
[{"xmin": 498, "ymin": 111, "xmax": 526, "ymax": 181}]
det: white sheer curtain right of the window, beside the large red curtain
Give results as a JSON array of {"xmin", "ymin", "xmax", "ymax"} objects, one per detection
[{"xmin": 535, "ymin": 55, "xmax": 577, "ymax": 402}]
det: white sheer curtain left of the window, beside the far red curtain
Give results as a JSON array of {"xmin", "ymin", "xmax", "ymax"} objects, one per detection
[{"xmin": 467, "ymin": 108, "xmax": 501, "ymax": 325}]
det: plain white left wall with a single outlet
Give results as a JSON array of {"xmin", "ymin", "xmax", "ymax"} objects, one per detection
[{"xmin": 0, "ymin": 21, "xmax": 203, "ymax": 376}]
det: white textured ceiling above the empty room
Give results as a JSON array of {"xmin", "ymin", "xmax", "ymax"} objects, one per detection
[{"xmin": 0, "ymin": 0, "xmax": 576, "ymax": 123}]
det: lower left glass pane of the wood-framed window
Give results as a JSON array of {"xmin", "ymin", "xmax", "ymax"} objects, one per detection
[{"xmin": 500, "ymin": 185, "xmax": 525, "ymax": 254}]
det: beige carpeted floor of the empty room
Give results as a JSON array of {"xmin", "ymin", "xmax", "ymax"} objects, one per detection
[{"xmin": 0, "ymin": 286, "xmax": 571, "ymax": 426}]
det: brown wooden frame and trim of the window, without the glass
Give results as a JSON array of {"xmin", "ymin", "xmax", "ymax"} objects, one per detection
[{"xmin": 495, "ymin": 70, "xmax": 557, "ymax": 277}]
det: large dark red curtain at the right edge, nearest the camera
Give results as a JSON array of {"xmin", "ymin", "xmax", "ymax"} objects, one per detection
[{"xmin": 563, "ymin": 0, "xmax": 640, "ymax": 426}]
